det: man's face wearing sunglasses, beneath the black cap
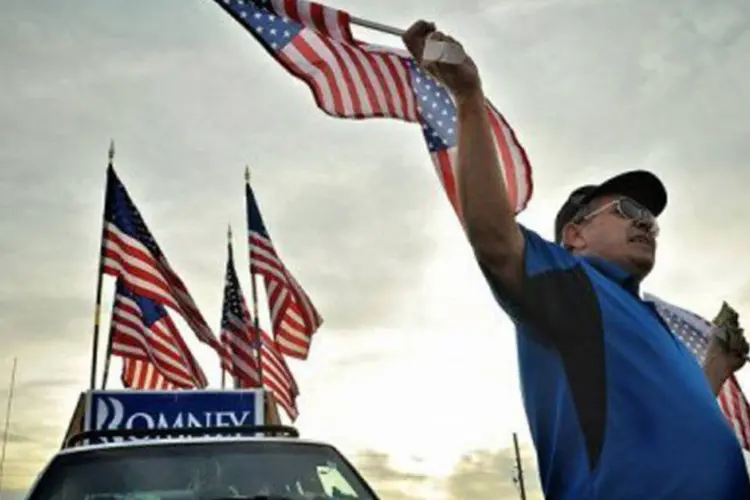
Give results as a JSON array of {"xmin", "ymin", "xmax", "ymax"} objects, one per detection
[{"xmin": 564, "ymin": 195, "xmax": 657, "ymax": 279}]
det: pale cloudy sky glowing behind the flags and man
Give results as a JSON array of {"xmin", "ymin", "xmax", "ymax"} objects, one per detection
[{"xmin": 0, "ymin": 0, "xmax": 750, "ymax": 500}]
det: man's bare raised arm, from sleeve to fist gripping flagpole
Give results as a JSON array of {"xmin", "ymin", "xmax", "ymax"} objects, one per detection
[{"xmin": 403, "ymin": 21, "xmax": 524, "ymax": 295}]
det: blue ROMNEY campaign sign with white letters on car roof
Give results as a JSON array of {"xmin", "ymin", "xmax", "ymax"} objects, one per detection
[{"xmin": 85, "ymin": 389, "xmax": 263, "ymax": 441}]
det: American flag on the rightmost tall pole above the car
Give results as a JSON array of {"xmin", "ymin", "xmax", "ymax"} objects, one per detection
[{"xmin": 245, "ymin": 183, "xmax": 323, "ymax": 359}]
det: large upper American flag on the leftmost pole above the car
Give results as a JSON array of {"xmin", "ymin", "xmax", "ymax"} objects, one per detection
[{"xmin": 101, "ymin": 164, "xmax": 221, "ymax": 352}]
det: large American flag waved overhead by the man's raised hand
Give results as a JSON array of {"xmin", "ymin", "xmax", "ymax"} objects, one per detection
[{"xmin": 215, "ymin": 0, "xmax": 533, "ymax": 218}]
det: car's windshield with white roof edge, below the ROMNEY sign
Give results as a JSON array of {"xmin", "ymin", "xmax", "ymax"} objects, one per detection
[{"xmin": 28, "ymin": 441, "xmax": 376, "ymax": 500}]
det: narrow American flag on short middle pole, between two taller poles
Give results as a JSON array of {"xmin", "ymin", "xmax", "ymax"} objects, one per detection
[{"xmin": 221, "ymin": 236, "xmax": 260, "ymax": 387}]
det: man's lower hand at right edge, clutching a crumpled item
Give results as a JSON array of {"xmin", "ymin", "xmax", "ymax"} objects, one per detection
[{"xmin": 703, "ymin": 302, "xmax": 750, "ymax": 394}]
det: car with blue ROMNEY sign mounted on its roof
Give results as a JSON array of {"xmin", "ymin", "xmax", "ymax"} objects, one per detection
[{"xmin": 27, "ymin": 389, "xmax": 378, "ymax": 500}]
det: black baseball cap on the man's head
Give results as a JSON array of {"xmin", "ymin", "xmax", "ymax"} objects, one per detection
[{"xmin": 555, "ymin": 170, "xmax": 667, "ymax": 243}]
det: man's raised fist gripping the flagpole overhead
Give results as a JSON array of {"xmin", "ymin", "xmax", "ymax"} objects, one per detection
[{"xmin": 402, "ymin": 20, "xmax": 482, "ymax": 101}]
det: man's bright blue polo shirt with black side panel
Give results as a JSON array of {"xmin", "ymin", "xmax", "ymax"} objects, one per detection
[{"xmin": 483, "ymin": 227, "xmax": 750, "ymax": 500}]
